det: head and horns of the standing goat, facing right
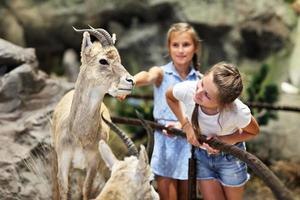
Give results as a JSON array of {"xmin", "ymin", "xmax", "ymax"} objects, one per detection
[{"xmin": 73, "ymin": 27, "xmax": 134, "ymax": 97}]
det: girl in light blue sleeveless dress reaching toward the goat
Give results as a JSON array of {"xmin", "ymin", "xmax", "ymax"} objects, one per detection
[{"xmin": 127, "ymin": 23, "xmax": 200, "ymax": 200}]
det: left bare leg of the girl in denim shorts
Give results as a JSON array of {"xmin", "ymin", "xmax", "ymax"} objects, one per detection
[{"xmin": 198, "ymin": 180, "xmax": 226, "ymax": 200}]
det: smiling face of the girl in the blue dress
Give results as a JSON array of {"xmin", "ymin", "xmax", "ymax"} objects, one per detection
[{"xmin": 168, "ymin": 31, "xmax": 197, "ymax": 67}]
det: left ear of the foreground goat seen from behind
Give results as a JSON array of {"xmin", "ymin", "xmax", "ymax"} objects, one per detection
[{"xmin": 99, "ymin": 140, "xmax": 118, "ymax": 170}]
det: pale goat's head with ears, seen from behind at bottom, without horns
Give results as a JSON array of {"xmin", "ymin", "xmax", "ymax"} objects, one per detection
[{"xmin": 96, "ymin": 140, "xmax": 159, "ymax": 200}]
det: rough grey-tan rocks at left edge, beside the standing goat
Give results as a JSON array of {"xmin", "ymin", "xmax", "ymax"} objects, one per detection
[{"xmin": 0, "ymin": 39, "xmax": 73, "ymax": 200}]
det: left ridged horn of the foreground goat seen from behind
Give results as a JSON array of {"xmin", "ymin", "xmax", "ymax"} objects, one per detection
[{"xmin": 101, "ymin": 113, "xmax": 139, "ymax": 157}]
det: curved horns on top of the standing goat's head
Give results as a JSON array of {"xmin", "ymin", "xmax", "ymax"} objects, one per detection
[{"xmin": 73, "ymin": 26, "xmax": 114, "ymax": 46}]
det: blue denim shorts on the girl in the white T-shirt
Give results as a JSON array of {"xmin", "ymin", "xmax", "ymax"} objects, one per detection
[{"xmin": 195, "ymin": 143, "xmax": 250, "ymax": 187}]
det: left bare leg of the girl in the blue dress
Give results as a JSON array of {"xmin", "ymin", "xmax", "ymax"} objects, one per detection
[{"xmin": 156, "ymin": 176, "xmax": 177, "ymax": 200}]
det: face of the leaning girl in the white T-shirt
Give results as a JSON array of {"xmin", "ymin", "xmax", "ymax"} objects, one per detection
[{"xmin": 194, "ymin": 73, "xmax": 220, "ymax": 113}]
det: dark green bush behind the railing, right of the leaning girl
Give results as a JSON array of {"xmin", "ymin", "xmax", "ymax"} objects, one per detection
[{"xmin": 246, "ymin": 64, "xmax": 279, "ymax": 125}]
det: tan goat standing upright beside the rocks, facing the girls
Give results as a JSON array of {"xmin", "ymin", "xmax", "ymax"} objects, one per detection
[{"xmin": 52, "ymin": 27, "xmax": 134, "ymax": 200}]
